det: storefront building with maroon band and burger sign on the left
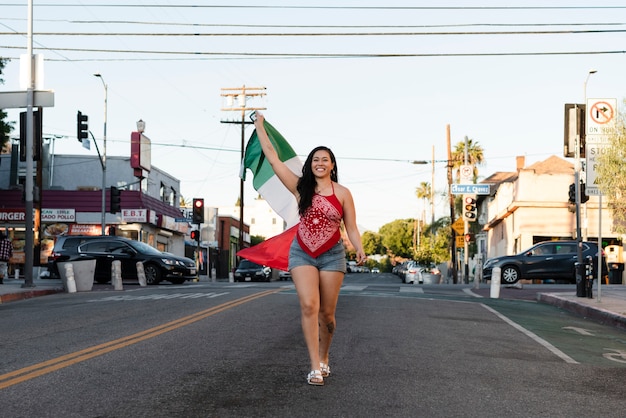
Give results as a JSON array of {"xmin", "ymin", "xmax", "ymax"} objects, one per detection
[{"xmin": 0, "ymin": 145, "xmax": 189, "ymax": 272}]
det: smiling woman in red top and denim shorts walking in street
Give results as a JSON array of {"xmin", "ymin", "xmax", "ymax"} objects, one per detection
[{"xmin": 254, "ymin": 112, "xmax": 366, "ymax": 385}]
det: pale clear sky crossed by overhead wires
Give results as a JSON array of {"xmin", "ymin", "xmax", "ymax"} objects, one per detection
[{"xmin": 0, "ymin": 0, "xmax": 626, "ymax": 232}]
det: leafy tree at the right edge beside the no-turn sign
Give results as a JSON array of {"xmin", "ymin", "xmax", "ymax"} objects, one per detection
[{"xmin": 596, "ymin": 100, "xmax": 626, "ymax": 234}]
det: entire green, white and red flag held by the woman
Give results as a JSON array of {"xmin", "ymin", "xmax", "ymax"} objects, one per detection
[{"xmin": 237, "ymin": 120, "xmax": 302, "ymax": 271}]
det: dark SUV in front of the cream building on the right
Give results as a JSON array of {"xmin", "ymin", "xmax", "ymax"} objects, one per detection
[{"xmin": 483, "ymin": 241, "xmax": 608, "ymax": 284}]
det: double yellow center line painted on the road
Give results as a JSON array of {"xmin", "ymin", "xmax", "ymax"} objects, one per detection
[{"xmin": 0, "ymin": 289, "xmax": 282, "ymax": 389}]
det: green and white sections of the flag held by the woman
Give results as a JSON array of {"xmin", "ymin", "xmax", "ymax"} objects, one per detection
[{"xmin": 240, "ymin": 120, "xmax": 302, "ymax": 228}]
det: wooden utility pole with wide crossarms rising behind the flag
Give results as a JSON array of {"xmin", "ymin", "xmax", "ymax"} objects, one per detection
[{"xmin": 221, "ymin": 85, "xmax": 266, "ymax": 258}]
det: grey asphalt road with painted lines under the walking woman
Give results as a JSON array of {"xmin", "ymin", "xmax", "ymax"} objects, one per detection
[{"xmin": 0, "ymin": 274, "xmax": 626, "ymax": 418}]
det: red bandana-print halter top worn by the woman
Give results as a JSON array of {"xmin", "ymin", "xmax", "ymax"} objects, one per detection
[{"xmin": 297, "ymin": 186, "xmax": 343, "ymax": 258}]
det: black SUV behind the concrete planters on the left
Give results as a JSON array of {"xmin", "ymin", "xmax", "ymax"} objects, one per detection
[{"xmin": 48, "ymin": 236, "xmax": 197, "ymax": 284}]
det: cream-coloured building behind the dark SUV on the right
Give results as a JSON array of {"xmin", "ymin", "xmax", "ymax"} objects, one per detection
[{"xmin": 479, "ymin": 156, "xmax": 622, "ymax": 259}]
